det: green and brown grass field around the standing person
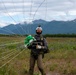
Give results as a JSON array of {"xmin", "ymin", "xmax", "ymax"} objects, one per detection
[{"xmin": 0, "ymin": 37, "xmax": 76, "ymax": 75}]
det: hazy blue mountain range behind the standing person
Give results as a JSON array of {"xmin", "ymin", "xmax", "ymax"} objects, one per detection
[{"xmin": 0, "ymin": 19, "xmax": 76, "ymax": 35}]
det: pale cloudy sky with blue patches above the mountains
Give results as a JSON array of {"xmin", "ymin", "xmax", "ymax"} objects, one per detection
[{"xmin": 0, "ymin": 0, "xmax": 76, "ymax": 27}]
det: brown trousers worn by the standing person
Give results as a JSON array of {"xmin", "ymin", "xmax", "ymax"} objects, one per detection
[{"xmin": 29, "ymin": 54, "xmax": 46, "ymax": 75}]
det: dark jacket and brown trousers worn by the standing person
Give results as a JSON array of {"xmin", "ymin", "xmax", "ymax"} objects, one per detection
[{"xmin": 28, "ymin": 34, "xmax": 48, "ymax": 75}]
